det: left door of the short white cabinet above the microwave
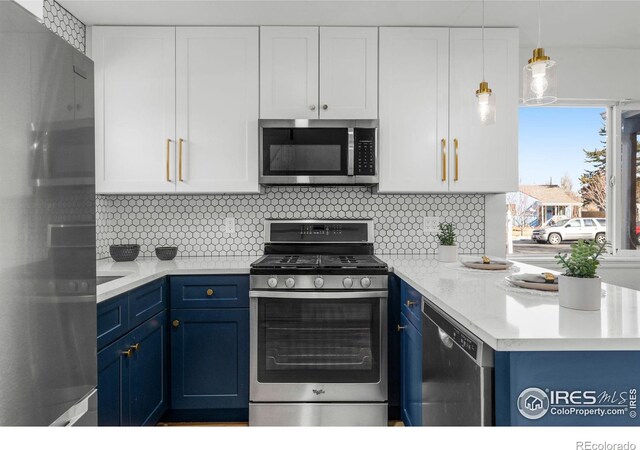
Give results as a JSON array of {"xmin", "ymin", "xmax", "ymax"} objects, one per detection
[{"xmin": 260, "ymin": 27, "xmax": 318, "ymax": 119}]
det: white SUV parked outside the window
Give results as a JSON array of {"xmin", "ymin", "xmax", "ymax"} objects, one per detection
[{"xmin": 531, "ymin": 218, "xmax": 607, "ymax": 245}]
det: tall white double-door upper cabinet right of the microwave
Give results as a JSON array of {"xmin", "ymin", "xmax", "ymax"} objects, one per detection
[{"xmin": 378, "ymin": 28, "xmax": 519, "ymax": 193}]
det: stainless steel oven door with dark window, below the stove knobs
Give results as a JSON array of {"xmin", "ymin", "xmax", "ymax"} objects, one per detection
[{"xmin": 250, "ymin": 291, "xmax": 387, "ymax": 402}]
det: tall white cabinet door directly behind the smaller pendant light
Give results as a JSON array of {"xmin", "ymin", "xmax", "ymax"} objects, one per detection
[{"xmin": 449, "ymin": 28, "xmax": 520, "ymax": 192}]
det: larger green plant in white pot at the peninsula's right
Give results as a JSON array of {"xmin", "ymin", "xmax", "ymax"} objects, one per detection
[{"xmin": 556, "ymin": 240, "xmax": 607, "ymax": 311}]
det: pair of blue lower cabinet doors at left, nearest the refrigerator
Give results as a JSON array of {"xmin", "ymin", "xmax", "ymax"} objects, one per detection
[{"xmin": 98, "ymin": 311, "xmax": 168, "ymax": 426}]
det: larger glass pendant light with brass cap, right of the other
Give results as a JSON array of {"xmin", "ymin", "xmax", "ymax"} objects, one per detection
[{"xmin": 522, "ymin": 0, "xmax": 558, "ymax": 106}]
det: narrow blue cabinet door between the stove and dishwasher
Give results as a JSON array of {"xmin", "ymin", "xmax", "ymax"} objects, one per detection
[{"xmin": 400, "ymin": 313, "xmax": 422, "ymax": 426}]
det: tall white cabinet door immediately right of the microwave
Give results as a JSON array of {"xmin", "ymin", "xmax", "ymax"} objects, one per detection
[{"xmin": 378, "ymin": 28, "xmax": 449, "ymax": 192}]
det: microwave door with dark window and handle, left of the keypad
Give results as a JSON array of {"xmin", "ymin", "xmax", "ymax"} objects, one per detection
[{"xmin": 260, "ymin": 127, "xmax": 355, "ymax": 184}]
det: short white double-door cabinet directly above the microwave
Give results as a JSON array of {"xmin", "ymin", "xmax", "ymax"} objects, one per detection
[{"xmin": 260, "ymin": 27, "xmax": 378, "ymax": 119}]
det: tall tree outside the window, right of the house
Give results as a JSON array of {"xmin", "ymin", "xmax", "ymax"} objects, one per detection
[{"xmin": 580, "ymin": 119, "xmax": 607, "ymax": 211}]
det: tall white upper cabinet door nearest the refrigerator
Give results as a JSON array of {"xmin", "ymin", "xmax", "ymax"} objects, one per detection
[{"xmin": 92, "ymin": 27, "xmax": 175, "ymax": 193}]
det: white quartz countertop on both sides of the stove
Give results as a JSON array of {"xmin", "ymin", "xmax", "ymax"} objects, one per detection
[{"xmin": 97, "ymin": 255, "xmax": 640, "ymax": 351}]
